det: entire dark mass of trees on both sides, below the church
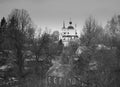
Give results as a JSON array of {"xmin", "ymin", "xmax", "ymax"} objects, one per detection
[{"xmin": 0, "ymin": 9, "xmax": 120, "ymax": 87}]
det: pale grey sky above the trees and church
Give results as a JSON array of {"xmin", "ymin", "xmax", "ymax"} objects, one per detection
[{"xmin": 0, "ymin": 0, "xmax": 120, "ymax": 30}]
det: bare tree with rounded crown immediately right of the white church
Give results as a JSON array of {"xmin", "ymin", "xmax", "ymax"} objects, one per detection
[{"xmin": 80, "ymin": 17, "xmax": 102, "ymax": 47}]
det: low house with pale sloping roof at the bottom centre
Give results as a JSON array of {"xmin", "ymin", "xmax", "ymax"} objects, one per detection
[{"xmin": 46, "ymin": 64, "xmax": 82, "ymax": 87}]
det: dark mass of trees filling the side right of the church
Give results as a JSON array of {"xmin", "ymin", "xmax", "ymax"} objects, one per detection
[{"xmin": 73, "ymin": 15, "xmax": 120, "ymax": 87}]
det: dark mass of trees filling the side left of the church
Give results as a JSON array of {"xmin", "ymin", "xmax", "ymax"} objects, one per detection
[{"xmin": 0, "ymin": 9, "xmax": 63, "ymax": 87}]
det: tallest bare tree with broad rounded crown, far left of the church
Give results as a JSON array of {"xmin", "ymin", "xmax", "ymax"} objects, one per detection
[{"xmin": 8, "ymin": 9, "xmax": 32, "ymax": 78}]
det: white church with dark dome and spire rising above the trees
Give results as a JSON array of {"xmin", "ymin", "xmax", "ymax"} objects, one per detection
[{"xmin": 60, "ymin": 21, "xmax": 78, "ymax": 46}]
